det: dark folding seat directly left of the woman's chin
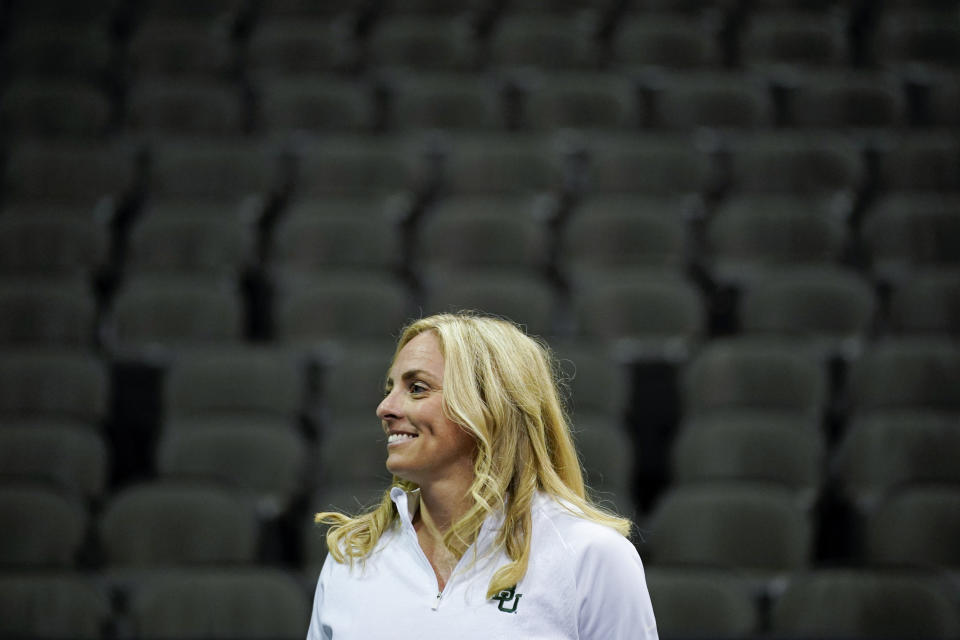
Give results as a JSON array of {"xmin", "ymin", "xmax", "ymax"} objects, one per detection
[{"xmin": 317, "ymin": 424, "xmax": 391, "ymax": 488}]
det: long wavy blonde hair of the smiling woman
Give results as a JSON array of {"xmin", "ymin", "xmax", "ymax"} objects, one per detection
[{"xmin": 315, "ymin": 312, "xmax": 631, "ymax": 597}]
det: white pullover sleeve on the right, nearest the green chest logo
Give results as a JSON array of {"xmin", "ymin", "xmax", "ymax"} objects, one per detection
[{"xmin": 577, "ymin": 531, "xmax": 658, "ymax": 640}]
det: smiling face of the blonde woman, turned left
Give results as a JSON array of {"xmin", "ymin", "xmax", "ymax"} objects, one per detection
[{"xmin": 377, "ymin": 331, "xmax": 475, "ymax": 486}]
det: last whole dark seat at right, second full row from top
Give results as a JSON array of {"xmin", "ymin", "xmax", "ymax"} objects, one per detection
[{"xmin": 786, "ymin": 69, "xmax": 907, "ymax": 128}]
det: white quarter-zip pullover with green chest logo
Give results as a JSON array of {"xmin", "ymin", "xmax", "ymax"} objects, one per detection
[{"xmin": 307, "ymin": 487, "xmax": 657, "ymax": 640}]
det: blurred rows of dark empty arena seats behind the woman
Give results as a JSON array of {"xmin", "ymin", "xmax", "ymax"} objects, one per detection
[{"xmin": 0, "ymin": 0, "xmax": 960, "ymax": 640}]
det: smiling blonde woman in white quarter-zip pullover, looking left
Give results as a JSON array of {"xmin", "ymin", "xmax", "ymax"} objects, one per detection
[{"xmin": 308, "ymin": 313, "xmax": 657, "ymax": 640}]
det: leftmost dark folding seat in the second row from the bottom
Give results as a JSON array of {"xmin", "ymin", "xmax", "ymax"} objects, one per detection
[{"xmin": 0, "ymin": 482, "xmax": 89, "ymax": 569}]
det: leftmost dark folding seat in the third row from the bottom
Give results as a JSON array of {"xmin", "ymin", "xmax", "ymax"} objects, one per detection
[{"xmin": 0, "ymin": 422, "xmax": 109, "ymax": 500}]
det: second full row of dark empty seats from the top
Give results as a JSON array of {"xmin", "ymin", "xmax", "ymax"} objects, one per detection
[{"xmin": 0, "ymin": 70, "xmax": 960, "ymax": 139}]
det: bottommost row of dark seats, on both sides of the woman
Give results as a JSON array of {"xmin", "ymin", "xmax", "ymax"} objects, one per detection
[{"xmin": 0, "ymin": 568, "xmax": 958, "ymax": 640}]
